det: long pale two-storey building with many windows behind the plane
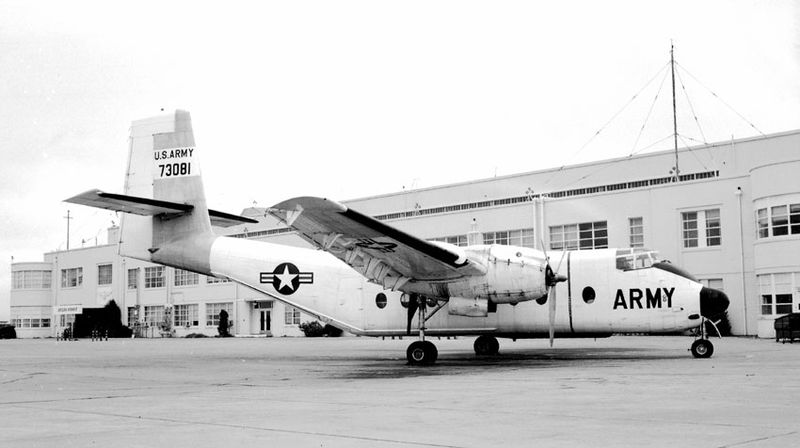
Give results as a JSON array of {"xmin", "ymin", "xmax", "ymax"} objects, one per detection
[{"xmin": 11, "ymin": 130, "xmax": 800, "ymax": 337}]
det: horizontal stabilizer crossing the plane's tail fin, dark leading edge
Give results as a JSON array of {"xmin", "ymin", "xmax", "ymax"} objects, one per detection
[{"xmin": 65, "ymin": 190, "xmax": 258, "ymax": 227}]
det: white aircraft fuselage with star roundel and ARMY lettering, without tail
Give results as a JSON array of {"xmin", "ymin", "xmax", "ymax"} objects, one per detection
[{"xmin": 208, "ymin": 237, "xmax": 702, "ymax": 338}]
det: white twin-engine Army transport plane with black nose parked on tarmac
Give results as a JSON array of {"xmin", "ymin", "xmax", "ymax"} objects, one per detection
[{"xmin": 67, "ymin": 111, "xmax": 728, "ymax": 364}]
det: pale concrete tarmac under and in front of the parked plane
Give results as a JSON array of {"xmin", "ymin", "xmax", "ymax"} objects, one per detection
[{"xmin": 0, "ymin": 336, "xmax": 800, "ymax": 448}]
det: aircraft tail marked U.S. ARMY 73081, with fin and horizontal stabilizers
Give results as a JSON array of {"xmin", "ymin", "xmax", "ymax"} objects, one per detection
[{"xmin": 67, "ymin": 110, "xmax": 257, "ymax": 273}]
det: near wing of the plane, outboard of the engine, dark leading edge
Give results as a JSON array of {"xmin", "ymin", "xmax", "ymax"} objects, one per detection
[{"xmin": 269, "ymin": 197, "xmax": 486, "ymax": 289}]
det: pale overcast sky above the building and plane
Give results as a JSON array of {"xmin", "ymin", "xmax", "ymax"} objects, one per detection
[{"xmin": 0, "ymin": 0, "xmax": 800, "ymax": 320}]
